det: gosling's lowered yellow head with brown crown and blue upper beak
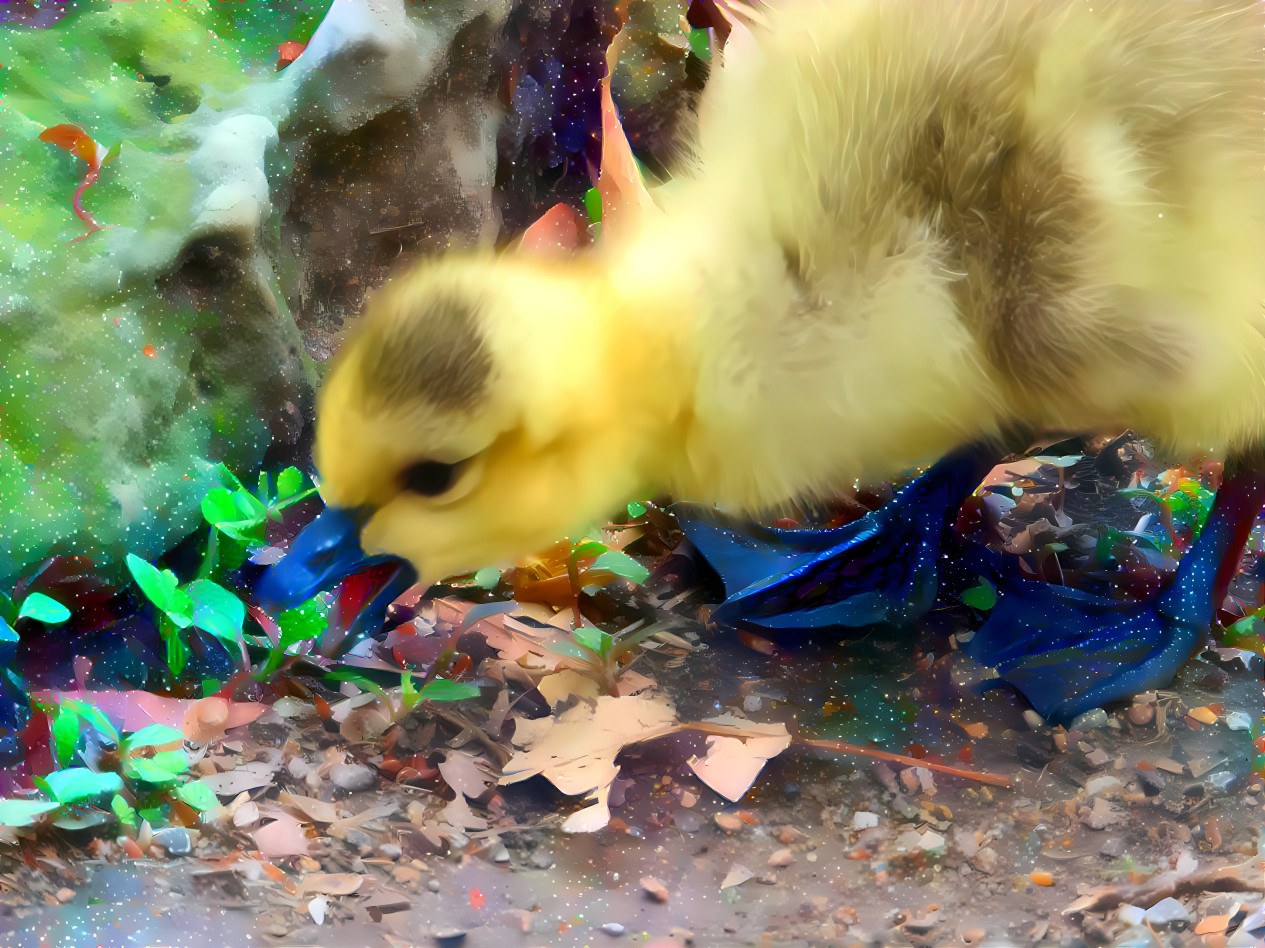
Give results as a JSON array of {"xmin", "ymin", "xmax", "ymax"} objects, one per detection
[{"xmin": 261, "ymin": 248, "xmax": 667, "ymax": 601}]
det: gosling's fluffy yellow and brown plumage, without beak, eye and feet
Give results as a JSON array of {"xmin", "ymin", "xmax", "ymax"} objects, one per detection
[{"xmin": 316, "ymin": 0, "xmax": 1265, "ymax": 580}]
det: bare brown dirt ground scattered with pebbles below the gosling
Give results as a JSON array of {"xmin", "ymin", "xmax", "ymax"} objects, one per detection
[{"xmin": 0, "ymin": 592, "xmax": 1265, "ymax": 948}]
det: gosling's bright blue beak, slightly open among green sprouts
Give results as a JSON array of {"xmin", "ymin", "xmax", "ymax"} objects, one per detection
[{"xmin": 254, "ymin": 508, "xmax": 417, "ymax": 640}]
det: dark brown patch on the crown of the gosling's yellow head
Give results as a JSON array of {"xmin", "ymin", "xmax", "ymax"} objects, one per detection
[{"xmin": 358, "ymin": 288, "xmax": 492, "ymax": 411}]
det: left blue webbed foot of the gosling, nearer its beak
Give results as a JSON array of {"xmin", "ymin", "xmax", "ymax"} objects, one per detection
[{"xmin": 678, "ymin": 448, "xmax": 994, "ymax": 630}]
